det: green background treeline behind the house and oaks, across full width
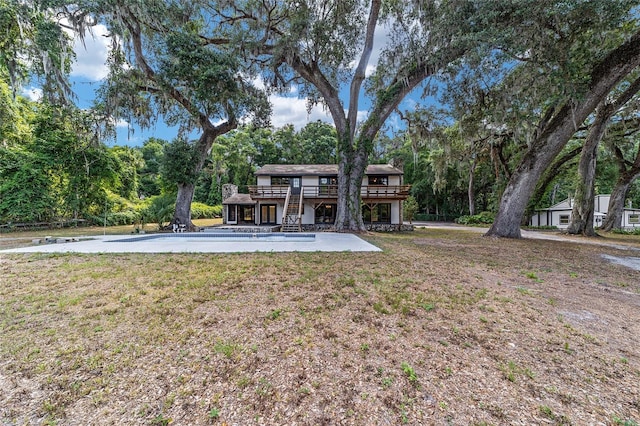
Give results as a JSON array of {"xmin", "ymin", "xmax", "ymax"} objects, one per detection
[{"xmin": 0, "ymin": 78, "xmax": 640, "ymax": 230}]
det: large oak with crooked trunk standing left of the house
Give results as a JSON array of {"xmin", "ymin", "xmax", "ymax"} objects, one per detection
[{"xmin": 83, "ymin": 0, "xmax": 269, "ymax": 227}]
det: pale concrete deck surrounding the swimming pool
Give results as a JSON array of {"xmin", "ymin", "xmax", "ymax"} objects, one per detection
[{"xmin": 0, "ymin": 232, "xmax": 382, "ymax": 253}]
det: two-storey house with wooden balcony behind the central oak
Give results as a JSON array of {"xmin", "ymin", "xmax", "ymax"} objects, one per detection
[{"xmin": 222, "ymin": 164, "xmax": 410, "ymax": 231}]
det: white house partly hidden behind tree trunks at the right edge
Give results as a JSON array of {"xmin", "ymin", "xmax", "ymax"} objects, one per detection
[{"xmin": 529, "ymin": 195, "xmax": 640, "ymax": 229}]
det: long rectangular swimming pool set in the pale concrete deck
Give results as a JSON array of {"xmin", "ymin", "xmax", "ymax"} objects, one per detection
[{"xmin": 112, "ymin": 232, "xmax": 316, "ymax": 243}]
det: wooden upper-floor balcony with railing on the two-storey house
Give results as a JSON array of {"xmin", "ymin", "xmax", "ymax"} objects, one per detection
[{"xmin": 249, "ymin": 185, "xmax": 411, "ymax": 200}]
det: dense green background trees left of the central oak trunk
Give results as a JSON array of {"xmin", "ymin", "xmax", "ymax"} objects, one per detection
[{"xmin": 0, "ymin": 87, "xmax": 344, "ymax": 226}]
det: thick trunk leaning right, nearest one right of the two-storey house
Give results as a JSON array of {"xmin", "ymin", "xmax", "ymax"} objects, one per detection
[{"xmin": 486, "ymin": 32, "xmax": 640, "ymax": 238}]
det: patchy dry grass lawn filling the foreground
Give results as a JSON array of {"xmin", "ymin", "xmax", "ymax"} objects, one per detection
[{"xmin": 0, "ymin": 229, "xmax": 640, "ymax": 425}]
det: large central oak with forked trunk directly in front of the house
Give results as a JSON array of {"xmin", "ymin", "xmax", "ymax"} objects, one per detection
[{"xmin": 219, "ymin": 0, "xmax": 475, "ymax": 231}]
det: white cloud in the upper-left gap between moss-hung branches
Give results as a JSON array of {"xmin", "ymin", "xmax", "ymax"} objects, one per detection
[{"xmin": 71, "ymin": 24, "xmax": 111, "ymax": 81}]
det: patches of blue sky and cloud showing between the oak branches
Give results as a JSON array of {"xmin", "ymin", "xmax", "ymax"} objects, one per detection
[{"xmin": 25, "ymin": 25, "xmax": 415, "ymax": 146}]
